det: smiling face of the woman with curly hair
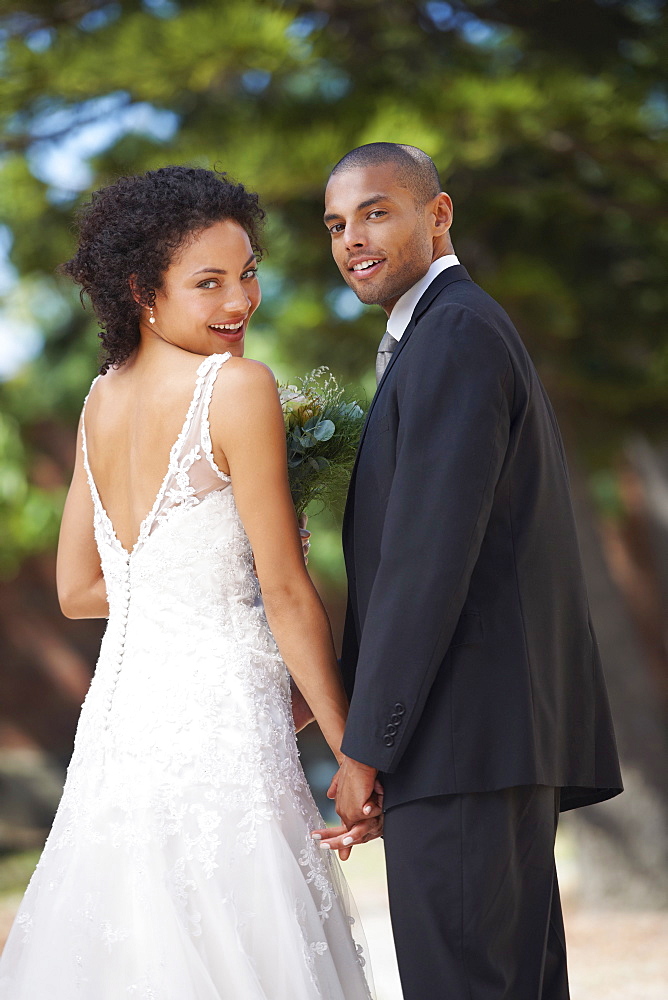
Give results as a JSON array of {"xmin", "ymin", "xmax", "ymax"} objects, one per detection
[{"xmin": 146, "ymin": 219, "xmax": 261, "ymax": 357}]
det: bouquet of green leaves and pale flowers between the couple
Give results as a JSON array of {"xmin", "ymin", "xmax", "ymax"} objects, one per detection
[{"xmin": 278, "ymin": 368, "xmax": 364, "ymax": 516}]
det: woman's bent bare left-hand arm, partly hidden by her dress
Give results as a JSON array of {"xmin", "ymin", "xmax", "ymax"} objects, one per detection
[{"xmin": 56, "ymin": 424, "xmax": 109, "ymax": 618}]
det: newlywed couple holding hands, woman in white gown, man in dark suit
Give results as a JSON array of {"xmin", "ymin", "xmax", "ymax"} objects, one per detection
[{"xmin": 0, "ymin": 143, "xmax": 621, "ymax": 1000}]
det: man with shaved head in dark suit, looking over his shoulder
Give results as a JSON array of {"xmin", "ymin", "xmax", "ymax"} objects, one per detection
[{"xmin": 316, "ymin": 142, "xmax": 622, "ymax": 1000}]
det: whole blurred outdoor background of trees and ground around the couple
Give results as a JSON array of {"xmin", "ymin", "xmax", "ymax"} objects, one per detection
[{"xmin": 0, "ymin": 0, "xmax": 668, "ymax": 1000}]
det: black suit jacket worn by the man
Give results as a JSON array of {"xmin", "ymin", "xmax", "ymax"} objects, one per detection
[{"xmin": 341, "ymin": 265, "xmax": 622, "ymax": 809}]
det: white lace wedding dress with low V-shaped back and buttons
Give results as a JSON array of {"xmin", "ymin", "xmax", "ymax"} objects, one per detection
[{"xmin": 0, "ymin": 354, "xmax": 372, "ymax": 1000}]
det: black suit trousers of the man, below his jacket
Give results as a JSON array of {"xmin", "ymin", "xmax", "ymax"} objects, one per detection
[{"xmin": 384, "ymin": 785, "xmax": 569, "ymax": 1000}]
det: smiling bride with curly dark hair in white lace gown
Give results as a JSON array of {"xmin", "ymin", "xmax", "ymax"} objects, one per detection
[{"xmin": 0, "ymin": 167, "xmax": 382, "ymax": 1000}]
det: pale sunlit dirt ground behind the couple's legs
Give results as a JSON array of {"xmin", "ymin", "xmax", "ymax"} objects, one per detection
[{"xmin": 0, "ymin": 840, "xmax": 668, "ymax": 1000}]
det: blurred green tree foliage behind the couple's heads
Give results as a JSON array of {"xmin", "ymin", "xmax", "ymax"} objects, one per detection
[{"xmin": 0, "ymin": 0, "xmax": 668, "ymax": 572}]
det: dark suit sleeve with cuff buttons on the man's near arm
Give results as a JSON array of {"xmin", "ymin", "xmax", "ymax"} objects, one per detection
[{"xmin": 341, "ymin": 305, "xmax": 514, "ymax": 773}]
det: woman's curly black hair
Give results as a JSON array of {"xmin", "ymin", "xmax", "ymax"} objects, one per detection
[{"xmin": 61, "ymin": 167, "xmax": 265, "ymax": 375}]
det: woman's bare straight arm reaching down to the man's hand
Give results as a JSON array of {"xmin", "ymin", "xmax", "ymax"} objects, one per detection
[{"xmin": 211, "ymin": 358, "xmax": 348, "ymax": 763}]
